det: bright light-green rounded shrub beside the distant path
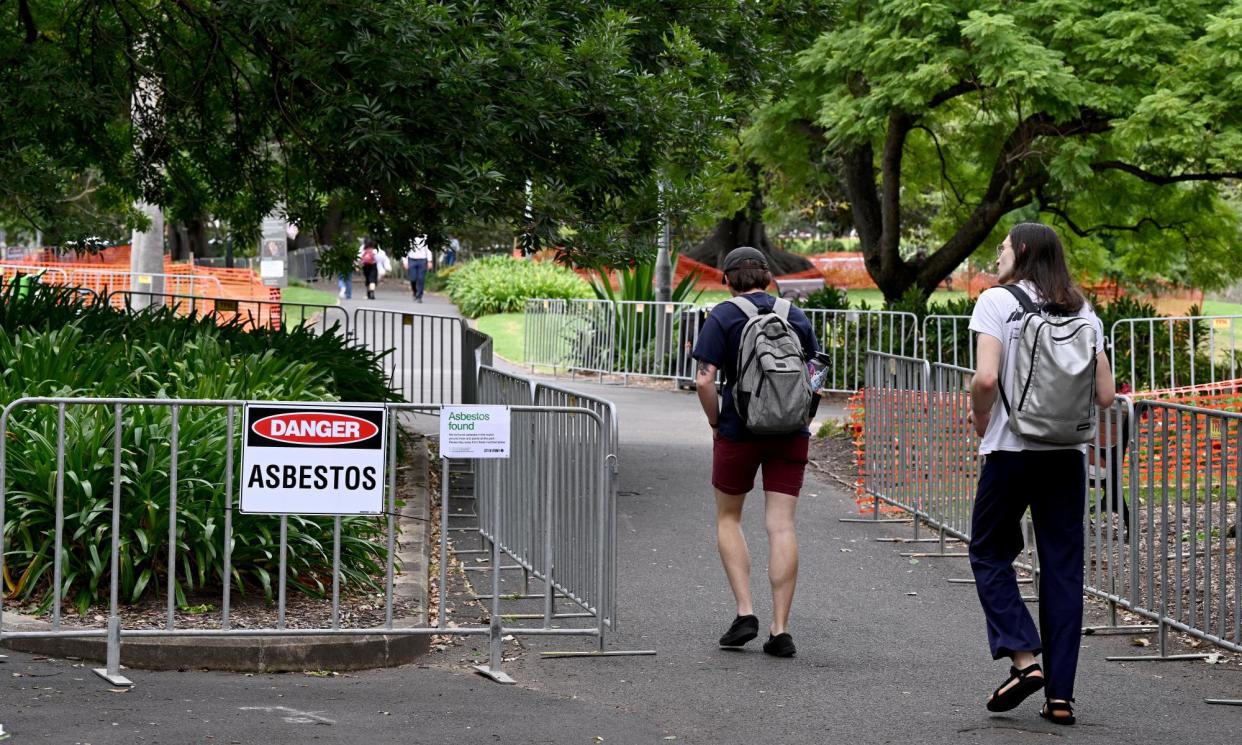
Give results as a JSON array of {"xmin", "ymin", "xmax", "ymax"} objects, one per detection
[{"xmin": 448, "ymin": 256, "xmax": 592, "ymax": 318}]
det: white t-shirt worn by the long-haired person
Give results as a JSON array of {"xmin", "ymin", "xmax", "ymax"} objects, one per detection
[{"xmin": 970, "ymin": 279, "xmax": 1104, "ymax": 456}]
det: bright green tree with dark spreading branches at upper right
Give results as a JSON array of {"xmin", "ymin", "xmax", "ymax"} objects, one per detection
[{"xmin": 751, "ymin": 0, "xmax": 1242, "ymax": 299}]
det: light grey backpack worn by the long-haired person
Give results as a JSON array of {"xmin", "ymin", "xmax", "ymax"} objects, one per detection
[{"xmin": 1001, "ymin": 284, "xmax": 1095, "ymax": 445}]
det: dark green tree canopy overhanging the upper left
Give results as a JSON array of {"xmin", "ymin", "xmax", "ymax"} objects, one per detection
[{"xmin": 0, "ymin": 0, "xmax": 786, "ymax": 260}]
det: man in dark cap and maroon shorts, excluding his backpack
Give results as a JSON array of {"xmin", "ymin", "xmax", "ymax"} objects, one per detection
[{"xmin": 694, "ymin": 246, "xmax": 818, "ymax": 657}]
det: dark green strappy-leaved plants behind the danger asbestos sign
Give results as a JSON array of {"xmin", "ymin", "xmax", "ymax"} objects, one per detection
[{"xmin": 0, "ymin": 288, "xmax": 386, "ymax": 608}]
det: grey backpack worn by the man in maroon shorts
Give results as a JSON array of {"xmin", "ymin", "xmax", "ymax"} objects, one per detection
[{"xmin": 730, "ymin": 297, "xmax": 812, "ymax": 435}]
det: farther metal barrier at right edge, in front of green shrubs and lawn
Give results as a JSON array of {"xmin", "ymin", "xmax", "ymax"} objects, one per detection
[{"xmin": 1109, "ymin": 315, "xmax": 1242, "ymax": 394}]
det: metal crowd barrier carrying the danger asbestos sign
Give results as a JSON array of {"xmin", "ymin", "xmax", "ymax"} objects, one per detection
[{"xmin": 0, "ymin": 397, "xmax": 615, "ymax": 684}]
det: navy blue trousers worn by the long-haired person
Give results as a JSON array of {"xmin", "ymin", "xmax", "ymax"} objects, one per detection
[{"xmin": 970, "ymin": 449, "xmax": 1087, "ymax": 699}]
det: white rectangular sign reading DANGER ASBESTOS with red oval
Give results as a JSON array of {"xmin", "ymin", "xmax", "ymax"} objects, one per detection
[{"xmin": 241, "ymin": 404, "xmax": 388, "ymax": 515}]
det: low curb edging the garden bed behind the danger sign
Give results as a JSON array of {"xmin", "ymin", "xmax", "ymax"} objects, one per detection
[{"xmin": 0, "ymin": 436, "xmax": 431, "ymax": 673}]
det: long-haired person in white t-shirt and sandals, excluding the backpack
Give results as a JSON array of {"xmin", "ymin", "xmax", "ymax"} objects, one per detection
[{"xmin": 970, "ymin": 222, "xmax": 1115, "ymax": 724}]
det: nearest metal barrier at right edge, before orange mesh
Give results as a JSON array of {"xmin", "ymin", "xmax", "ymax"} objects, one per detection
[{"xmin": 1088, "ymin": 401, "xmax": 1242, "ymax": 659}]
